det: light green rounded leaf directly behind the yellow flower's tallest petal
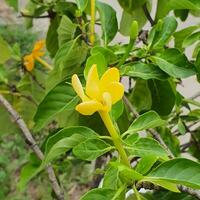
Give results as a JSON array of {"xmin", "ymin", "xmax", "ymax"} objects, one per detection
[{"xmin": 84, "ymin": 53, "xmax": 107, "ymax": 78}]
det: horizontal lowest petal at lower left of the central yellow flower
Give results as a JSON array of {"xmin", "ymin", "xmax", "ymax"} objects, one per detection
[{"xmin": 76, "ymin": 100, "xmax": 103, "ymax": 115}]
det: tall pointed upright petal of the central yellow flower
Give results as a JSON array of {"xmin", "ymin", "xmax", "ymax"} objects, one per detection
[{"xmin": 86, "ymin": 65, "xmax": 101, "ymax": 100}]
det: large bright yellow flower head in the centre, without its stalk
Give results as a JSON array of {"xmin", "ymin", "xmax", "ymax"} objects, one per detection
[{"xmin": 72, "ymin": 65, "xmax": 124, "ymax": 115}]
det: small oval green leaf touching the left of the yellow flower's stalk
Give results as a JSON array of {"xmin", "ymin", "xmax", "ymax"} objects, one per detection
[{"xmin": 73, "ymin": 139, "xmax": 113, "ymax": 161}]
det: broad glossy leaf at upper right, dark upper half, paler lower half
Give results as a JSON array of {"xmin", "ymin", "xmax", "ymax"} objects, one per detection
[{"xmin": 150, "ymin": 49, "xmax": 196, "ymax": 78}]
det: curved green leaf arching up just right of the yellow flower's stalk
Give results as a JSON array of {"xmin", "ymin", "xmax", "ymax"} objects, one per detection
[{"xmin": 126, "ymin": 111, "xmax": 166, "ymax": 133}]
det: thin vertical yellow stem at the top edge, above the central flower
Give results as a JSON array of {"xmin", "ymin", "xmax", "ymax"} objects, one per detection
[{"xmin": 90, "ymin": 0, "xmax": 96, "ymax": 46}]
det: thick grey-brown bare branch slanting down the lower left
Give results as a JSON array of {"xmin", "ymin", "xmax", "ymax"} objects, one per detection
[{"xmin": 0, "ymin": 94, "xmax": 64, "ymax": 200}]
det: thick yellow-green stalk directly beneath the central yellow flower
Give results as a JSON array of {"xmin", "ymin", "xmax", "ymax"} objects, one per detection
[{"xmin": 99, "ymin": 111, "xmax": 130, "ymax": 167}]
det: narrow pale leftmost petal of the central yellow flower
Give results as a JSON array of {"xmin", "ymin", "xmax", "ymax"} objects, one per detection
[{"xmin": 72, "ymin": 74, "xmax": 87, "ymax": 101}]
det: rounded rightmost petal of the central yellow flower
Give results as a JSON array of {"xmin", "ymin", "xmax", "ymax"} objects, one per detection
[{"xmin": 105, "ymin": 82, "xmax": 124, "ymax": 104}]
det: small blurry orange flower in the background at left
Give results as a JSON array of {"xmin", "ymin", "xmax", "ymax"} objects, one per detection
[{"xmin": 24, "ymin": 40, "xmax": 45, "ymax": 71}]
